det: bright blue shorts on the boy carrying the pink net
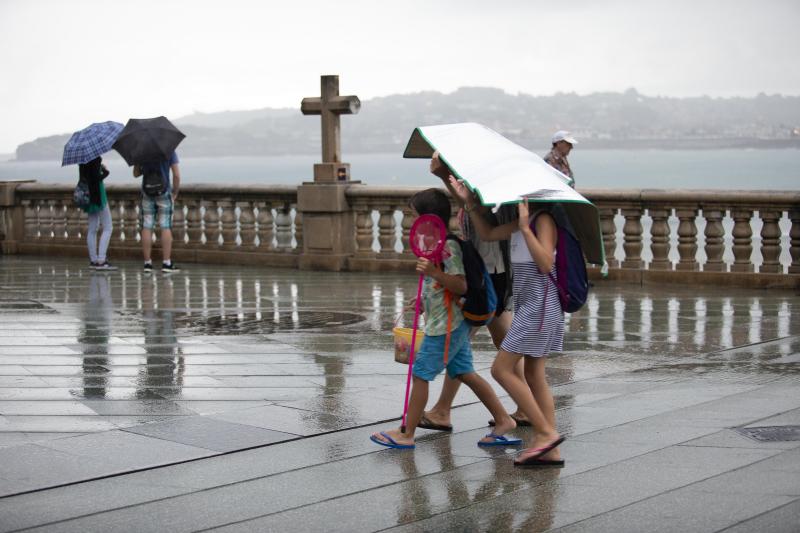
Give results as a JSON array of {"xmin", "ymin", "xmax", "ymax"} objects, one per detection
[{"xmin": 412, "ymin": 322, "xmax": 475, "ymax": 381}]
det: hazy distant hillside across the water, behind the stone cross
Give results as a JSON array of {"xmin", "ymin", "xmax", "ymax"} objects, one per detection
[{"xmin": 16, "ymin": 87, "xmax": 800, "ymax": 160}]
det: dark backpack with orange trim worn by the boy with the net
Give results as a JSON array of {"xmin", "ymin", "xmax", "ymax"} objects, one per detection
[{"xmin": 447, "ymin": 234, "xmax": 497, "ymax": 326}]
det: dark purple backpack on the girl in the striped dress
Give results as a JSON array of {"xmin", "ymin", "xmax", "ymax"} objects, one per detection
[{"xmin": 531, "ymin": 213, "xmax": 589, "ymax": 313}]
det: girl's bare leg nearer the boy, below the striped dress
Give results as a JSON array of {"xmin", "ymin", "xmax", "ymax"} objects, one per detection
[{"xmin": 492, "ymin": 350, "xmax": 558, "ymax": 458}]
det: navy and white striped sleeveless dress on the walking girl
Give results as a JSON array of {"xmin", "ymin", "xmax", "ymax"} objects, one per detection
[{"xmin": 500, "ymin": 220, "xmax": 564, "ymax": 357}]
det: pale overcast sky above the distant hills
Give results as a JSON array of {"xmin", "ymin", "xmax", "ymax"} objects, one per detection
[{"xmin": 0, "ymin": 0, "xmax": 800, "ymax": 153}]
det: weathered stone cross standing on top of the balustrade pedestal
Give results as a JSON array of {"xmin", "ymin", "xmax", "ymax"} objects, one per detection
[{"xmin": 300, "ymin": 76, "xmax": 361, "ymax": 181}]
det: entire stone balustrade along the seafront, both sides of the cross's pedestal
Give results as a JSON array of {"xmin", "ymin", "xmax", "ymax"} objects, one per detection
[{"xmin": 0, "ymin": 182, "xmax": 800, "ymax": 287}]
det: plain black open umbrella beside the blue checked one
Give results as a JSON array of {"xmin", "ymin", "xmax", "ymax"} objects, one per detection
[{"xmin": 113, "ymin": 117, "xmax": 186, "ymax": 165}]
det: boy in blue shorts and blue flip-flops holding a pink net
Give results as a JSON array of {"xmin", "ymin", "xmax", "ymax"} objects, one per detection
[{"xmin": 370, "ymin": 189, "xmax": 522, "ymax": 449}]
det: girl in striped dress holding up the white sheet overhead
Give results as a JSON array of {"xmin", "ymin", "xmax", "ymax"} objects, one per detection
[{"xmin": 451, "ymin": 178, "xmax": 564, "ymax": 467}]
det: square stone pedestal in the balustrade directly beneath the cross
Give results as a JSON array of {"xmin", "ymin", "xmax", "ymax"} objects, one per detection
[{"xmin": 297, "ymin": 182, "xmax": 356, "ymax": 271}]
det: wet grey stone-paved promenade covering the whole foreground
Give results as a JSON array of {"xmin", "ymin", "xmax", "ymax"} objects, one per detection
[{"xmin": 0, "ymin": 257, "xmax": 800, "ymax": 532}]
